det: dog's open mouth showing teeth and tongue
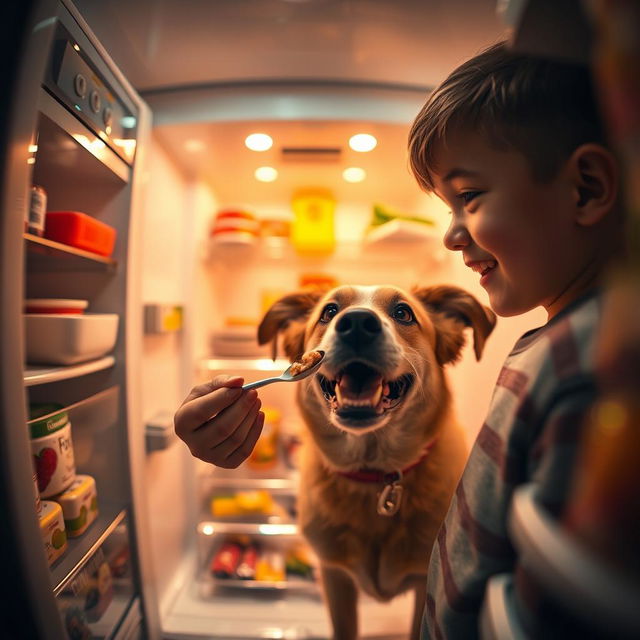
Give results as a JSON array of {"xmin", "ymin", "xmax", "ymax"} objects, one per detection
[{"xmin": 317, "ymin": 362, "xmax": 414, "ymax": 424}]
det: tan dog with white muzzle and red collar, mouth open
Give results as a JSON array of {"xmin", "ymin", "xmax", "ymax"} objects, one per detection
[{"xmin": 258, "ymin": 285, "xmax": 496, "ymax": 640}]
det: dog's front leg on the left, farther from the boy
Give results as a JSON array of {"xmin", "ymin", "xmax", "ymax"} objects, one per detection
[{"xmin": 320, "ymin": 565, "xmax": 358, "ymax": 640}]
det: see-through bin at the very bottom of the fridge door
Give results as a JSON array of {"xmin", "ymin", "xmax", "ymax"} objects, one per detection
[{"xmin": 56, "ymin": 511, "xmax": 135, "ymax": 640}]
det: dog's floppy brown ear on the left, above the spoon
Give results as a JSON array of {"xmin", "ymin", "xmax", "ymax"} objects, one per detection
[{"xmin": 258, "ymin": 289, "xmax": 325, "ymax": 361}]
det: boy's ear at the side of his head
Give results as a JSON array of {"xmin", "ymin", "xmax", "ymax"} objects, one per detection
[{"xmin": 570, "ymin": 143, "xmax": 618, "ymax": 227}]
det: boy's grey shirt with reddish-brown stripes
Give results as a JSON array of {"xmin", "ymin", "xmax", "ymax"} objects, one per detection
[{"xmin": 422, "ymin": 294, "xmax": 601, "ymax": 640}]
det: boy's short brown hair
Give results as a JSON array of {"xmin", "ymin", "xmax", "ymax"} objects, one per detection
[{"xmin": 409, "ymin": 42, "xmax": 606, "ymax": 191}]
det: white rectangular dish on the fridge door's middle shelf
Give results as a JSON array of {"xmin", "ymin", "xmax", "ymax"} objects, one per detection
[{"xmin": 24, "ymin": 313, "xmax": 119, "ymax": 364}]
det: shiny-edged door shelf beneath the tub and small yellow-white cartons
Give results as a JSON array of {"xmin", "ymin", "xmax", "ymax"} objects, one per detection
[{"xmin": 51, "ymin": 503, "xmax": 127, "ymax": 596}]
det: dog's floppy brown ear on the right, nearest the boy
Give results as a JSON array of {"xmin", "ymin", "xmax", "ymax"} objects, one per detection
[{"xmin": 412, "ymin": 285, "xmax": 496, "ymax": 364}]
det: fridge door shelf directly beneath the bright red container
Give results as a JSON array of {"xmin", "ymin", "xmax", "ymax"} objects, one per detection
[{"xmin": 22, "ymin": 233, "xmax": 118, "ymax": 271}]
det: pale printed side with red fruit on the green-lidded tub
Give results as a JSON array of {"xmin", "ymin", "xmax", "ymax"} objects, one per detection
[{"xmin": 31, "ymin": 423, "xmax": 76, "ymax": 498}]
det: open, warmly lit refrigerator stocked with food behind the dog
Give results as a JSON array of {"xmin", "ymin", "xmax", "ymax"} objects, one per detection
[{"xmin": 0, "ymin": 0, "xmax": 560, "ymax": 640}]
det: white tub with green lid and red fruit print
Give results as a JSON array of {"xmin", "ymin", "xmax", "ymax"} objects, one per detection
[{"xmin": 28, "ymin": 404, "xmax": 76, "ymax": 498}]
